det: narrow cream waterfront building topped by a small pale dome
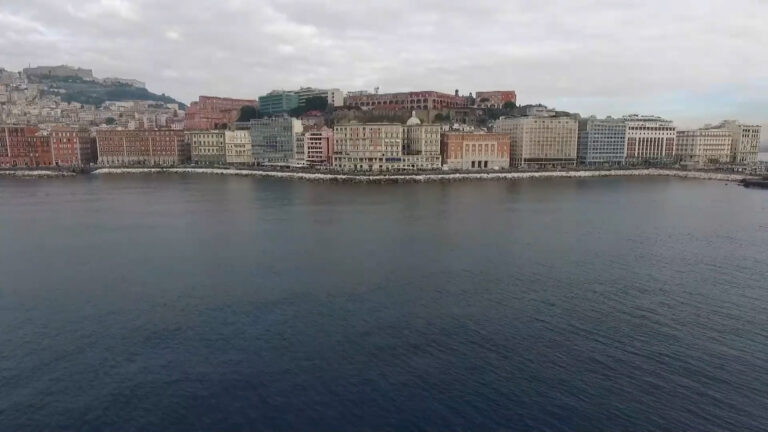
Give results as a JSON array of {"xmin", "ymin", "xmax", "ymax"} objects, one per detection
[{"xmin": 403, "ymin": 111, "xmax": 442, "ymax": 170}]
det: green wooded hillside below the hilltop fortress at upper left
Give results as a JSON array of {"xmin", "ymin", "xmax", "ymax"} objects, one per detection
[{"xmin": 30, "ymin": 76, "xmax": 186, "ymax": 108}]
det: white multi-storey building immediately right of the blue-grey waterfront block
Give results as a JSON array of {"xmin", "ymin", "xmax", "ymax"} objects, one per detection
[{"xmin": 623, "ymin": 114, "xmax": 677, "ymax": 163}]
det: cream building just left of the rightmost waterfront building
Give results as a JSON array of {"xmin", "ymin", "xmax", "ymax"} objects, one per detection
[{"xmin": 675, "ymin": 128, "xmax": 732, "ymax": 166}]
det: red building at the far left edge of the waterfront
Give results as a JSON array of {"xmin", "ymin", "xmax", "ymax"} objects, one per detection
[{"xmin": 0, "ymin": 126, "xmax": 53, "ymax": 167}]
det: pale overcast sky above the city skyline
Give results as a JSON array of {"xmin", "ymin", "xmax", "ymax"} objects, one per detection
[{"xmin": 0, "ymin": 0, "xmax": 768, "ymax": 135}]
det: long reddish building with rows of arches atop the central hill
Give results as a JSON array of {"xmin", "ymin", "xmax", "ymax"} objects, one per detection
[{"xmin": 345, "ymin": 91, "xmax": 467, "ymax": 111}]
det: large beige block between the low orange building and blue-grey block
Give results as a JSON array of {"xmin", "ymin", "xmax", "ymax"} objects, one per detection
[{"xmin": 493, "ymin": 110, "xmax": 579, "ymax": 167}]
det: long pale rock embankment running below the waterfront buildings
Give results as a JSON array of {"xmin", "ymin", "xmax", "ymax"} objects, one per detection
[{"xmin": 92, "ymin": 168, "xmax": 748, "ymax": 183}]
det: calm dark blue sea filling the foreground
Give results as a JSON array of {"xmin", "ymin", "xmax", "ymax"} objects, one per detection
[{"xmin": 0, "ymin": 174, "xmax": 768, "ymax": 432}]
